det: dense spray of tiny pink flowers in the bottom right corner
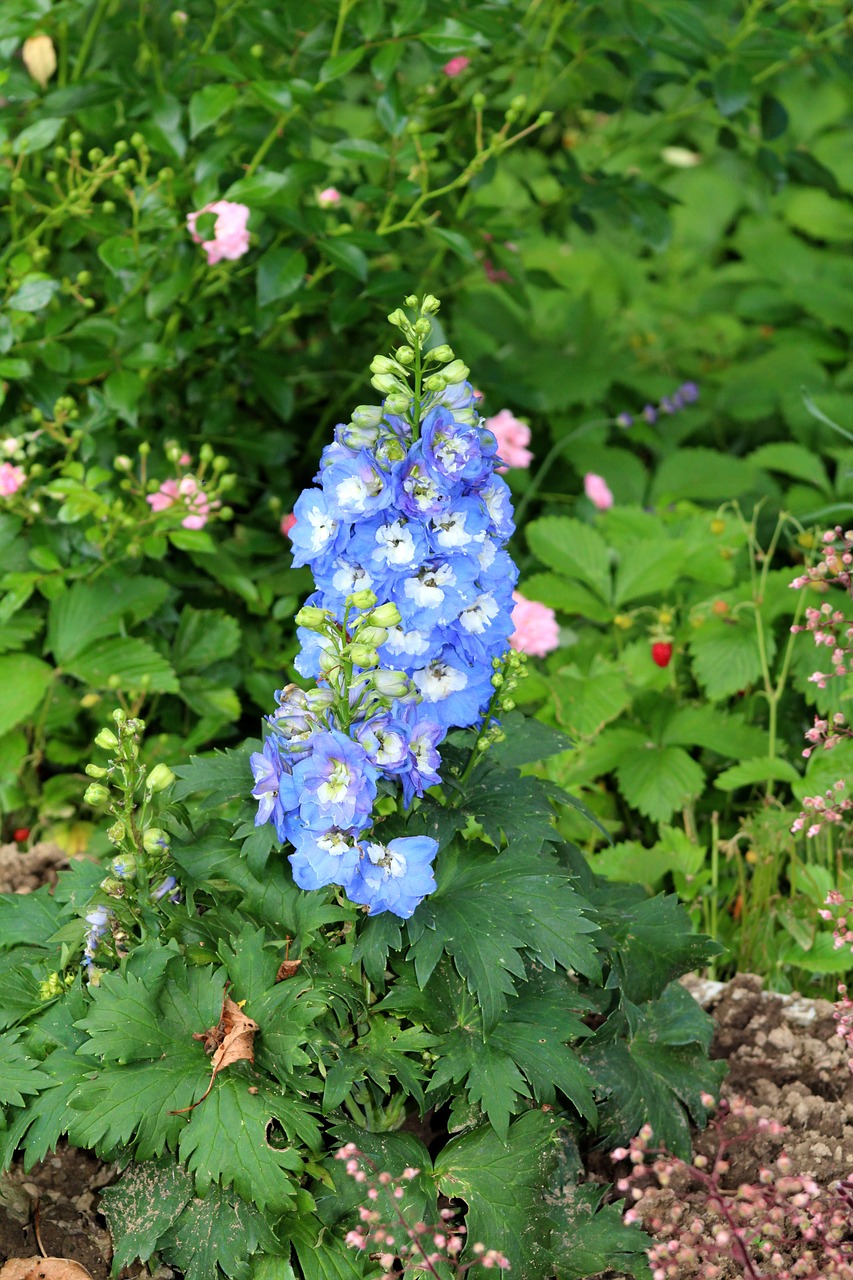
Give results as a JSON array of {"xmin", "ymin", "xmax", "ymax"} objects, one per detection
[{"xmin": 611, "ymin": 1094, "xmax": 853, "ymax": 1280}]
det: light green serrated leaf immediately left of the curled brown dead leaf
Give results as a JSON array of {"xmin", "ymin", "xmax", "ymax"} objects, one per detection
[{"xmin": 68, "ymin": 1044, "xmax": 204, "ymax": 1160}]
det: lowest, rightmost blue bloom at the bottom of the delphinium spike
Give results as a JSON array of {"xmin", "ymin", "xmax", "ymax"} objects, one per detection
[{"xmin": 346, "ymin": 836, "xmax": 438, "ymax": 920}]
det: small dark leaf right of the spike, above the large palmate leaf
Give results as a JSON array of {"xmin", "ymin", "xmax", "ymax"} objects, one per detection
[{"xmin": 451, "ymin": 760, "xmax": 556, "ymax": 852}]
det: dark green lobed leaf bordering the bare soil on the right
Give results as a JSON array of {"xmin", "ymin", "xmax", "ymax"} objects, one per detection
[{"xmin": 581, "ymin": 983, "xmax": 725, "ymax": 1160}]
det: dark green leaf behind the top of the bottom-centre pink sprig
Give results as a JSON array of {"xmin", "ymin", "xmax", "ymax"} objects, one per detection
[{"xmin": 313, "ymin": 1123, "xmax": 438, "ymax": 1226}]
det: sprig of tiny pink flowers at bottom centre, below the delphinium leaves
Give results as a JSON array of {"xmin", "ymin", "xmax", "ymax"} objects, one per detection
[{"xmin": 336, "ymin": 1142, "xmax": 510, "ymax": 1280}]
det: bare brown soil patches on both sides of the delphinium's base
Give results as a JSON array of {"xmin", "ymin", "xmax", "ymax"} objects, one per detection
[{"xmin": 0, "ymin": 845, "xmax": 853, "ymax": 1280}]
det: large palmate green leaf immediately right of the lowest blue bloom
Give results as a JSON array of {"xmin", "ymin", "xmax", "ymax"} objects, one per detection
[{"xmin": 407, "ymin": 842, "xmax": 598, "ymax": 1029}]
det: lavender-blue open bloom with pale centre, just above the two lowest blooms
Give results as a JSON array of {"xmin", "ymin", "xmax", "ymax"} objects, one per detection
[{"xmin": 293, "ymin": 730, "xmax": 377, "ymax": 832}]
